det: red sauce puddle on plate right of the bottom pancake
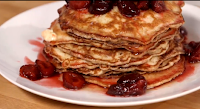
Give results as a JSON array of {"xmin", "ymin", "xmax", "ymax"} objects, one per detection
[{"xmin": 175, "ymin": 62, "xmax": 195, "ymax": 82}]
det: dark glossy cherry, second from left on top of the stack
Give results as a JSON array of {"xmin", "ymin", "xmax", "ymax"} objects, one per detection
[{"xmin": 88, "ymin": 0, "xmax": 112, "ymax": 15}]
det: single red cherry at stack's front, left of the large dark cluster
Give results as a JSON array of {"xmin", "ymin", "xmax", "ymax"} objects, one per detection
[{"xmin": 63, "ymin": 71, "xmax": 86, "ymax": 90}]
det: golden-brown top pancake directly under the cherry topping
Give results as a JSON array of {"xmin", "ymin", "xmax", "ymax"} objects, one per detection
[{"xmin": 59, "ymin": 1, "xmax": 184, "ymax": 44}]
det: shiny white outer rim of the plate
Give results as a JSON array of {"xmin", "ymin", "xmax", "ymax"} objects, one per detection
[{"xmin": 0, "ymin": 1, "xmax": 200, "ymax": 107}]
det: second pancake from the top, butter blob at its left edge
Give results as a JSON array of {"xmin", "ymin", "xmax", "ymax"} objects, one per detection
[{"xmin": 42, "ymin": 19, "xmax": 178, "ymax": 53}]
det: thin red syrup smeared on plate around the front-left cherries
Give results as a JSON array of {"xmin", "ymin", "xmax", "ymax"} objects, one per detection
[{"xmin": 20, "ymin": 37, "xmax": 107, "ymax": 93}]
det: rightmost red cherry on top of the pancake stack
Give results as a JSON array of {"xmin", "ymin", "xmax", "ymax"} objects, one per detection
[{"xmin": 150, "ymin": 1, "xmax": 166, "ymax": 13}]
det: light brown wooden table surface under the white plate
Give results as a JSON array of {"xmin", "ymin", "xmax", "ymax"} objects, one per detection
[{"xmin": 0, "ymin": 1, "xmax": 200, "ymax": 109}]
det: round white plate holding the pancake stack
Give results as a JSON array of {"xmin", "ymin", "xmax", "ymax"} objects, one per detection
[{"xmin": 0, "ymin": 2, "xmax": 200, "ymax": 106}]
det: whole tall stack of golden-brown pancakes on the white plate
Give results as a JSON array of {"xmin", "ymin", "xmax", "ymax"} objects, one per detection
[{"xmin": 42, "ymin": 1, "xmax": 184, "ymax": 89}]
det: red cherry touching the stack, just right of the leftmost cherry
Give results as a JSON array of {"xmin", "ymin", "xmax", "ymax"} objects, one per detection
[{"xmin": 35, "ymin": 60, "xmax": 56, "ymax": 77}]
